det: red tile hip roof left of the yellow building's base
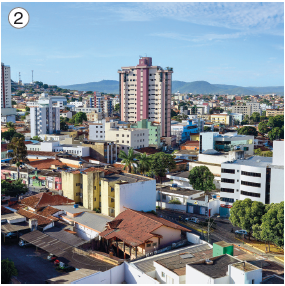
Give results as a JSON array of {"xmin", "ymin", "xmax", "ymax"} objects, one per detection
[{"xmin": 21, "ymin": 193, "xmax": 74, "ymax": 209}]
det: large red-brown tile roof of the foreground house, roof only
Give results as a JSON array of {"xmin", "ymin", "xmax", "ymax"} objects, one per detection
[{"xmin": 100, "ymin": 209, "xmax": 190, "ymax": 246}]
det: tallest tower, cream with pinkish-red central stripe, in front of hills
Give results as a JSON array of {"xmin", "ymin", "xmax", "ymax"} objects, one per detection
[{"xmin": 118, "ymin": 57, "xmax": 173, "ymax": 137}]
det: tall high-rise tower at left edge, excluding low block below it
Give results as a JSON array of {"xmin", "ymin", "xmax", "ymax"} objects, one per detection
[{"xmin": 1, "ymin": 63, "xmax": 12, "ymax": 108}]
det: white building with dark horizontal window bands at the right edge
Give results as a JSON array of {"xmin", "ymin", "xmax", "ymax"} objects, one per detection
[{"xmin": 220, "ymin": 141, "xmax": 284, "ymax": 204}]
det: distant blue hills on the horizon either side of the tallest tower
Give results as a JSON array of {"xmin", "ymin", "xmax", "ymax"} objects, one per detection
[{"xmin": 60, "ymin": 80, "xmax": 284, "ymax": 95}]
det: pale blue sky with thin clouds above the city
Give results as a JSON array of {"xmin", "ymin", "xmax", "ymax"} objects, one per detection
[{"xmin": 1, "ymin": 2, "xmax": 284, "ymax": 86}]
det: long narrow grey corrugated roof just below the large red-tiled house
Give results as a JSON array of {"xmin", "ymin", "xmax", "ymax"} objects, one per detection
[{"xmin": 132, "ymin": 244, "xmax": 211, "ymax": 273}]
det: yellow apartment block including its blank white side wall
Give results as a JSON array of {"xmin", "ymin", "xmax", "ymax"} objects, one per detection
[{"xmin": 61, "ymin": 167, "xmax": 156, "ymax": 217}]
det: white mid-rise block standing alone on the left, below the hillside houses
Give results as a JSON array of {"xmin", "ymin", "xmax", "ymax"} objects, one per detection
[{"xmin": 30, "ymin": 98, "xmax": 60, "ymax": 138}]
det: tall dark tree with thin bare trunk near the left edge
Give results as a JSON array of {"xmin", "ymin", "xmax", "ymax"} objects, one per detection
[{"xmin": 8, "ymin": 137, "xmax": 29, "ymax": 179}]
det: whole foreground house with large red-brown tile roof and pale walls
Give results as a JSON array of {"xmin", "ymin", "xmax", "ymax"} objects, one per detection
[{"xmin": 100, "ymin": 209, "xmax": 190, "ymax": 259}]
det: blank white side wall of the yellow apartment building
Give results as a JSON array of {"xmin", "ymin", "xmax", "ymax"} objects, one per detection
[{"xmin": 115, "ymin": 177, "xmax": 156, "ymax": 216}]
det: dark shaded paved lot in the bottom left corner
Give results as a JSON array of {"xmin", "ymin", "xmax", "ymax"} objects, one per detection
[{"xmin": 1, "ymin": 241, "xmax": 62, "ymax": 284}]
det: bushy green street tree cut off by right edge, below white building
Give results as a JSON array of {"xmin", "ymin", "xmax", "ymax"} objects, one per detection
[{"xmin": 253, "ymin": 202, "xmax": 284, "ymax": 251}]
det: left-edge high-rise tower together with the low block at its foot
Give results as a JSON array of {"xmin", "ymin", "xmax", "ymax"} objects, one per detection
[{"xmin": 1, "ymin": 63, "xmax": 16, "ymax": 123}]
